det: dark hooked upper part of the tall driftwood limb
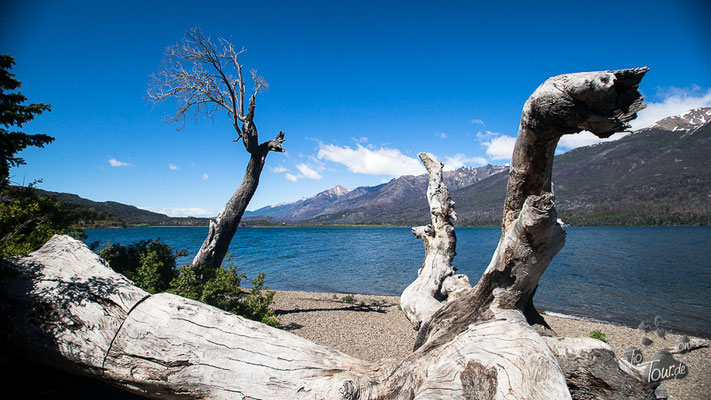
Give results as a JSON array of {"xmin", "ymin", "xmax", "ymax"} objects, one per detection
[{"xmin": 502, "ymin": 67, "xmax": 649, "ymax": 231}]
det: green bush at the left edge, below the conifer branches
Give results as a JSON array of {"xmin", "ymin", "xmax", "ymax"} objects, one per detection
[{"xmin": 0, "ymin": 187, "xmax": 84, "ymax": 259}]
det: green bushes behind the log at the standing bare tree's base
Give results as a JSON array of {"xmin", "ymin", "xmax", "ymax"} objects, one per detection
[{"xmin": 98, "ymin": 239, "xmax": 278, "ymax": 326}]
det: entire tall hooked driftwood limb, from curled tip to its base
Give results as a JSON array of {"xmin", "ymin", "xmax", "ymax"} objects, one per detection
[{"xmin": 415, "ymin": 68, "xmax": 648, "ymax": 347}]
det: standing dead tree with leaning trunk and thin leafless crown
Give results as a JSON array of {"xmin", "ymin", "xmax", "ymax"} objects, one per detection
[{"xmin": 147, "ymin": 27, "xmax": 284, "ymax": 269}]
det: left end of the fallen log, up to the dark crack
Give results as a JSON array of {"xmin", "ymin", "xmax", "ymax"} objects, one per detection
[{"xmin": 0, "ymin": 236, "xmax": 149, "ymax": 373}]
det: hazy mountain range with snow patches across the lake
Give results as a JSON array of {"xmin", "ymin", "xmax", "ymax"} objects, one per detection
[{"xmin": 245, "ymin": 108, "xmax": 711, "ymax": 225}]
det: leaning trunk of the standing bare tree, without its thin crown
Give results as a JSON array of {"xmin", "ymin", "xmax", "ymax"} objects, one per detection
[{"xmin": 193, "ymin": 128, "xmax": 284, "ymax": 271}]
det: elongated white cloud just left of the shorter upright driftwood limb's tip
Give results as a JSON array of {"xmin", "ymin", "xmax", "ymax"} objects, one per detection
[{"xmin": 317, "ymin": 144, "xmax": 426, "ymax": 177}]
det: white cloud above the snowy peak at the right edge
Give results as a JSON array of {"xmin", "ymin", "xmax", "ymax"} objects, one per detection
[{"xmin": 631, "ymin": 86, "xmax": 711, "ymax": 130}]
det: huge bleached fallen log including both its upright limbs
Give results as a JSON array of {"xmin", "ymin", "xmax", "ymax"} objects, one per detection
[{"xmin": 0, "ymin": 68, "xmax": 654, "ymax": 400}]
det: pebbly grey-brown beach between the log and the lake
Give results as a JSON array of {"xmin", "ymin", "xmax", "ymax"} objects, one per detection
[{"xmin": 273, "ymin": 292, "xmax": 711, "ymax": 400}]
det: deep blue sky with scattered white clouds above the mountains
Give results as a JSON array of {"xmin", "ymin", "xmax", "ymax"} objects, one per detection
[{"xmin": 0, "ymin": 0, "xmax": 711, "ymax": 216}]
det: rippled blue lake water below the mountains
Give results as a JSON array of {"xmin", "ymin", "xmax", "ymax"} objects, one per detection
[{"xmin": 86, "ymin": 227, "xmax": 711, "ymax": 336}]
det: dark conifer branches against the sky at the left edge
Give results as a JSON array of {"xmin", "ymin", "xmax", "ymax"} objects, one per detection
[{"xmin": 0, "ymin": 54, "xmax": 54, "ymax": 188}]
